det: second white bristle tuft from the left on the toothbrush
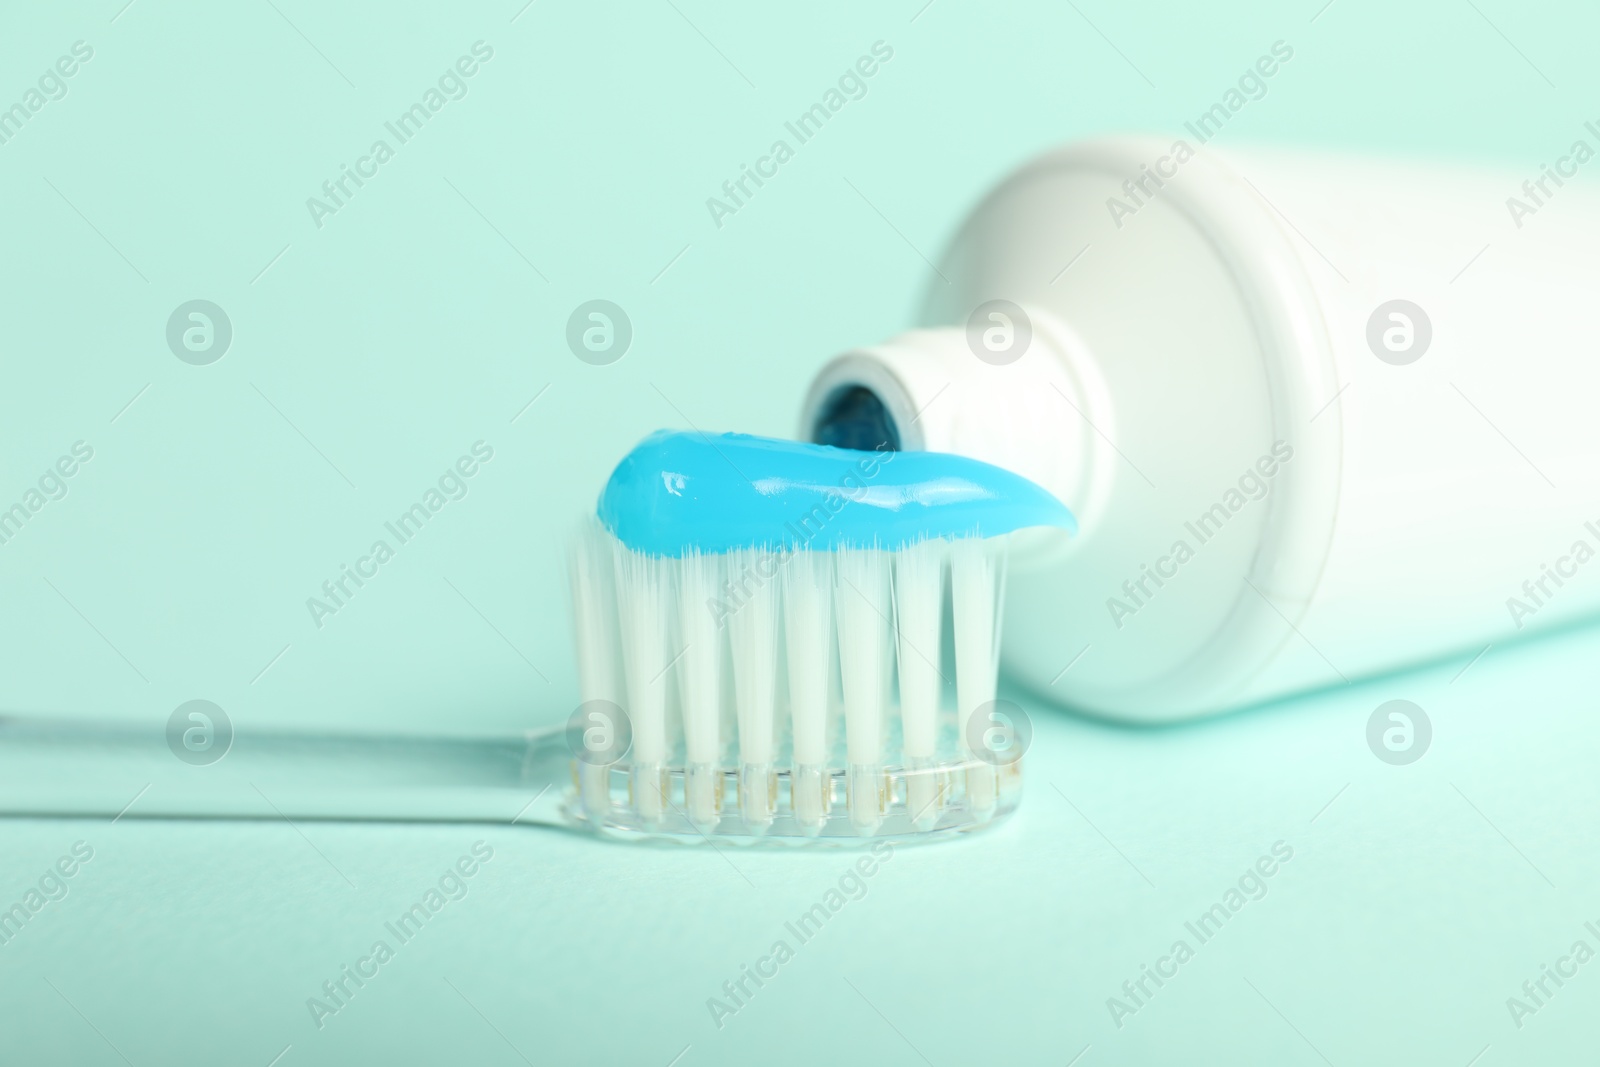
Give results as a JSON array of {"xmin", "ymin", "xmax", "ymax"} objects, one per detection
[{"xmin": 604, "ymin": 544, "xmax": 672, "ymax": 821}]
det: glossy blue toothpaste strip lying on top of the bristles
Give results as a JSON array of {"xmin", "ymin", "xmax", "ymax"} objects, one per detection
[{"xmin": 598, "ymin": 430, "xmax": 1078, "ymax": 557}]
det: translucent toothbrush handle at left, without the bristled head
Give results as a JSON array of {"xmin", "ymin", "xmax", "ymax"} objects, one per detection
[{"xmin": 0, "ymin": 717, "xmax": 571, "ymax": 825}]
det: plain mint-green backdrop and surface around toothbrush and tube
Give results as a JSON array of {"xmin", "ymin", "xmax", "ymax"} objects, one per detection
[{"xmin": 0, "ymin": 0, "xmax": 1600, "ymax": 1067}]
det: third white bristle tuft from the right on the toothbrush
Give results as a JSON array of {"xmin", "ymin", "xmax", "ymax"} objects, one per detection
[{"xmin": 835, "ymin": 549, "xmax": 891, "ymax": 833}]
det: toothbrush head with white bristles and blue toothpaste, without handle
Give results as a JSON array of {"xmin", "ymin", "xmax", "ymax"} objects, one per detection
[{"xmin": 571, "ymin": 430, "xmax": 1077, "ymax": 840}]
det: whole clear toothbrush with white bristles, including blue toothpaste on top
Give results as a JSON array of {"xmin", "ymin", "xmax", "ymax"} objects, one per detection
[{"xmin": 0, "ymin": 432, "xmax": 1075, "ymax": 843}]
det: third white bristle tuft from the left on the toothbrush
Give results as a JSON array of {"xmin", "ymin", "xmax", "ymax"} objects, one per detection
[{"xmin": 677, "ymin": 549, "xmax": 725, "ymax": 829}]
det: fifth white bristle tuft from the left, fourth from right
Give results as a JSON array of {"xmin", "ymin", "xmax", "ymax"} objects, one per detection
[{"xmin": 781, "ymin": 549, "xmax": 834, "ymax": 832}]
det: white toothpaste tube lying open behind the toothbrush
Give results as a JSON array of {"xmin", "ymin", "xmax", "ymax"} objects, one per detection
[{"xmin": 802, "ymin": 138, "xmax": 1600, "ymax": 720}]
